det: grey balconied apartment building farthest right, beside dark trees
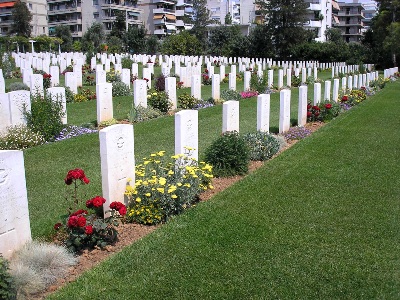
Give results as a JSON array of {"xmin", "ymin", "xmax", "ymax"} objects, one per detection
[{"xmin": 335, "ymin": 0, "xmax": 364, "ymax": 43}]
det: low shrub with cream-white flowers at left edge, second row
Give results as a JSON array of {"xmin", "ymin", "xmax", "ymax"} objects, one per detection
[{"xmin": 0, "ymin": 125, "xmax": 46, "ymax": 150}]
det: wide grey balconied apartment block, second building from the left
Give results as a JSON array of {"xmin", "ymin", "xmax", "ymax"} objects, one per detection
[{"xmin": 47, "ymin": 0, "xmax": 143, "ymax": 40}]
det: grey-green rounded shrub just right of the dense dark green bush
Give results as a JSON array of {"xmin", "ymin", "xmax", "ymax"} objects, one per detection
[{"xmin": 244, "ymin": 131, "xmax": 280, "ymax": 161}]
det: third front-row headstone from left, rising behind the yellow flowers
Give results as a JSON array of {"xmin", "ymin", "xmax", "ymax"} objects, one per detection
[{"xmin": 175, "ymin": 110, "xmax": 199, "ymax": 160}]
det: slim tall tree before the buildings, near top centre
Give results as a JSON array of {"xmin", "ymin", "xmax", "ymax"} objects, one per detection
[{"xmin": 191, "ymin": 0, "xmax": 213, "ymax": 47}]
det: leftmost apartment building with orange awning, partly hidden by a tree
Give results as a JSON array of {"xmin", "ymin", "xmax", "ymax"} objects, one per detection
[{"xmin": 0, "ymin": 0, "xmax": 49, "ymax": 36}]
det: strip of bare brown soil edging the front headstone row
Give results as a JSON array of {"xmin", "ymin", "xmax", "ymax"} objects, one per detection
[{"xmin": 30, "ymin": 122, "xmax": 324, "ymax": 300}]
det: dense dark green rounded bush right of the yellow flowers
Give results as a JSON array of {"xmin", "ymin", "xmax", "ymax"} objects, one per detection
[{"xmin": 205, "ymin": 132, "xmax": 250, "ymax": 177}]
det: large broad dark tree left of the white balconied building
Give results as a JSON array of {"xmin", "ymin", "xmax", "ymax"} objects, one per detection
[{"xmin": 255, "ymin": 0, "xmax": 309, "ymax": 59}]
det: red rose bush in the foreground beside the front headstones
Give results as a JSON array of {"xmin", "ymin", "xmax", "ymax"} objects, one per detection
[{"xmin": 54, "ymin": 169, "xmax": 126, "ymax": 252}]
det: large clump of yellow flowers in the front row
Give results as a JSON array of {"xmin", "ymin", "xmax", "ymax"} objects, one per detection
[{"xmin": 125, "ymin": 148, "xmax": 213, "ymax": 225}]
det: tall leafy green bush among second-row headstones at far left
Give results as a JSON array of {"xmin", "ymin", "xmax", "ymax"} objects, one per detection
[{"xmin": 24, "ymin": 94, "xmax": 64, "ymax": 141}]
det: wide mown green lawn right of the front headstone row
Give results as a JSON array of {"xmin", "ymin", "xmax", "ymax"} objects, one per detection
[{"xmin": 44, "ymin": 81, "xmax": 400, "ymax": 299}]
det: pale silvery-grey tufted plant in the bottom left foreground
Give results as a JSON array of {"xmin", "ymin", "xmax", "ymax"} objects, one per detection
[{"xmin": 10, "ymin": 241, "xmax": 77, "ymax": 298}]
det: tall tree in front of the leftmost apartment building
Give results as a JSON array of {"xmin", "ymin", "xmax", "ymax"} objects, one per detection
[{"xmin": 11, "ymin": 0, "xmax": 32, "ymax": 37}]
